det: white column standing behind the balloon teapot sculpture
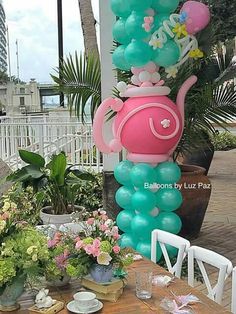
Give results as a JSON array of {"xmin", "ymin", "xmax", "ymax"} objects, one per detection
[{"xmin": 99, "ymin": 0, "xmax": 119, "ymax": 171}]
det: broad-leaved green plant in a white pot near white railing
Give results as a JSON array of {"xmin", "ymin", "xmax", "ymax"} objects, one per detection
[{"xmin": 8, "ymin": 150, "xmax": 95, "ymax": 225}]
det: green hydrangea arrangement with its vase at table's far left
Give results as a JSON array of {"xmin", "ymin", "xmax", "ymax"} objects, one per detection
[{"xmin": 0, "ymin": 203, "xmax": 49, "ymax": 311}]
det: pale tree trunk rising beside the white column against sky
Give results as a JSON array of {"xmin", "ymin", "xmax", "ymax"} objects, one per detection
[{"xmin": 78, "ymin": 0, "xmax": 99, "ymax": 56}]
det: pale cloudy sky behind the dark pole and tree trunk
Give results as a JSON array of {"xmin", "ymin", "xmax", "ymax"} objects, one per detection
[{"xmin": 3, "ymin": 0, "xmax": 98, "ymax": 82}]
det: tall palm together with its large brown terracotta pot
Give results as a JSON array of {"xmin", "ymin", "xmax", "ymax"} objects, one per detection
[{"xmin": 166, "ymin": 39, "xmax": 236, "ymax": 238}]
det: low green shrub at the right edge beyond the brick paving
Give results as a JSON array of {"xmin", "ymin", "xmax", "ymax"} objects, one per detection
[{"xmin": 212, "ymin": 131, "xmax": 236, "ymax": 150}]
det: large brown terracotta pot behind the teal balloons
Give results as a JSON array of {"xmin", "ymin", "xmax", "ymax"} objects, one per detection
[{"xmin": 176, "ymin": 165, "xmax": 211, "ymax": 239}]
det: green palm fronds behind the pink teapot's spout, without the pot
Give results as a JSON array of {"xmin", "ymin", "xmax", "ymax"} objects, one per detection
[{"xmin": 169, "ymin": 39, "xmax": 236, "ymax": 158}]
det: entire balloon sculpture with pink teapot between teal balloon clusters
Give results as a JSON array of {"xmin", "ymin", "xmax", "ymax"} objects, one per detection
[{"xmin": 93, "ymin": 0, "xmax": 210, "ymax": 260}]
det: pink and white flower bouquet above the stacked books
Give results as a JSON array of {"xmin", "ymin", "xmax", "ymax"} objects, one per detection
[{"xmin": 75, "ymin": 210, "xmax": 132, "ymax": 273}]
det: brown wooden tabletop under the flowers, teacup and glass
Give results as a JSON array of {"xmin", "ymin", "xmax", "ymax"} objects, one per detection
[{"xmin": 6, "ymin": 259, "xmax": 231, "ymax": 314}]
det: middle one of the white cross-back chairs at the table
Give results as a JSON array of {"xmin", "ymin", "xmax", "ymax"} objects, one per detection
[{"xmin": 188, "ymin": 246, "xmax": 233, "ymax": 304}]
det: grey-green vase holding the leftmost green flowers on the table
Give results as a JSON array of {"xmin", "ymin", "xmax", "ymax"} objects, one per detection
[{"xmin": 0, "ymin": 275, "xmax": 26, "ymax": 312}]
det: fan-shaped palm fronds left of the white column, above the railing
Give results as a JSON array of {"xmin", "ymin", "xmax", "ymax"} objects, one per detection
[{"xmin": 51, "ymin": 52, "xmax": 101, "ymax": 122}]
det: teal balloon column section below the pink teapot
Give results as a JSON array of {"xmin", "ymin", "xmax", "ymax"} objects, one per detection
[{"xmin": 114, "ymin": 160, "xmax": 182, "ymax": 260}]
